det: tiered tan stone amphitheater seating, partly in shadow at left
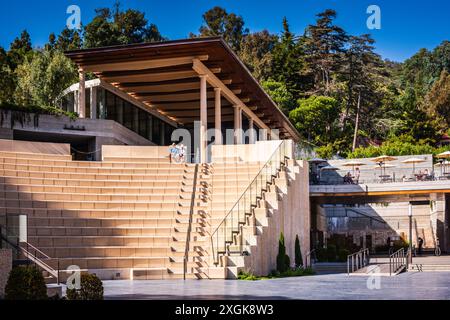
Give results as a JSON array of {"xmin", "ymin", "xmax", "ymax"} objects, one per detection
[{"xmin": 0, "ymin": 141, "xmax": 307, "ymax": 279}]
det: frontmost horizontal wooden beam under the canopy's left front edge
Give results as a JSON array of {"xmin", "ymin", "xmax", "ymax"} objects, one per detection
[{"xmin": 84, "ymin": 55, "xmax": 208, "ymax": 72}]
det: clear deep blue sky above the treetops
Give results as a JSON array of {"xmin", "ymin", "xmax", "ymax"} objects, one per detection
[{"xmin": 0, "ymin": 0, "xmax": 450, "ymax": 61}]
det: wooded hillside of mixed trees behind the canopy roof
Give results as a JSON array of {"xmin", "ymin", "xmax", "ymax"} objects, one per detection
[{"xmin": 0, "ymin": 3, "xmax": 450, "ymax": 158}]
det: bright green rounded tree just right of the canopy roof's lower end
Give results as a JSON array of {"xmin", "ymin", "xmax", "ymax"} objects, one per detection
[{"xmin": 289, "ymin": 96, "xmax": 340, "ymax": 146}]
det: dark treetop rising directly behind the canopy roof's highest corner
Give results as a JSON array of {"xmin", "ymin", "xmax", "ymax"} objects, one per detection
[{"xmin": 191, "ymin": 6, "xmax": 248, "ymax": 52}]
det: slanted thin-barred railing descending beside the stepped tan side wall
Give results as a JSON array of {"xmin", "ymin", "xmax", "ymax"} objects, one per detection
[{"xmin": 211, "ymin": 140, "xmax": 289, "ymax": 266}]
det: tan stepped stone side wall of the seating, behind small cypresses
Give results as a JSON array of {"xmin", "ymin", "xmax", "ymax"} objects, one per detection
[{"xmin": 232, "ymin": 161, "xmax": 310, "ymax": 277}]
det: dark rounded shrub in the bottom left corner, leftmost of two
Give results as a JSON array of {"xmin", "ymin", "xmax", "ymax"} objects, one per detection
[{"xmin": 5, "ymin": 266, "xmax": 48, "ymax": 300}]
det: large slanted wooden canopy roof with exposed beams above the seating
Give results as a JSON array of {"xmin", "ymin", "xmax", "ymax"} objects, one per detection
[{"xmin": 65, "ymin": 37, "xmax": 300, "ymax": 141}]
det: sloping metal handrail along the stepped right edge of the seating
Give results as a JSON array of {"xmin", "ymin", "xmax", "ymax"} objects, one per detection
[{"xmin": 211, "ymin": 141, "xmax": 289, "ymax": 265}]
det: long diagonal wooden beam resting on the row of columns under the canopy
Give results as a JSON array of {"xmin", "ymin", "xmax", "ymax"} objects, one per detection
[{"xmin": 192, "ymin": 59, "xmax": 269, "ymax": 129}]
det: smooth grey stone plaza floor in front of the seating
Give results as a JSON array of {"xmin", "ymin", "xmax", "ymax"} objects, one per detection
[{"xmin": 98, "ymin": 272, "xmax": 450, "ymax": 300}]
